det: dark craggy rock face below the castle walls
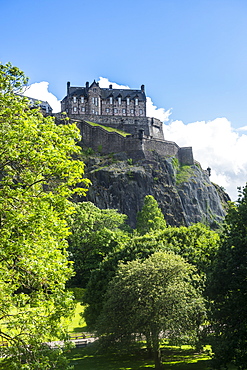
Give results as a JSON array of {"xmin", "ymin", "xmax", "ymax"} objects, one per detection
[{"xmin": 85, "ymin": 153, "xmax": 230, "ymax": 227}]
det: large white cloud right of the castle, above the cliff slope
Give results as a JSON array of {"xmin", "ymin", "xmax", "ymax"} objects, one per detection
[{"xmin": 164, "ymin": 118, "xmax": 247, "ymax": 200}]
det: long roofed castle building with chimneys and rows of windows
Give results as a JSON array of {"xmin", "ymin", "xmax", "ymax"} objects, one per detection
[{"xmin": 61, "ymin": 81, "xmax": 146, "ymax": 117}]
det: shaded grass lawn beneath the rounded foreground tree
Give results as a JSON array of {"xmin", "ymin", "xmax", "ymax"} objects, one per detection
[{"xmin": 69, "ymin": 343, "xmax": 210, "ymax": 370}]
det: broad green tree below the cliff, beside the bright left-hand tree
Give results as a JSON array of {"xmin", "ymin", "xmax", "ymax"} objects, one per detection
[{"xmin": 68, "ymin": 202, "xmax": 128, "ymax": 288}]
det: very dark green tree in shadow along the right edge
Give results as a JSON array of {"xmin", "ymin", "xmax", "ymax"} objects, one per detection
[{"xmin": 208, "ymin": 187, "xmax": 247, "ymax": 369}]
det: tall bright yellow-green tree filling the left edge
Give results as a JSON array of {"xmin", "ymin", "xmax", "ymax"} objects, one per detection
[{"xmin": 0, "ymin": 64, "xmax": 88, "ymax": 370}]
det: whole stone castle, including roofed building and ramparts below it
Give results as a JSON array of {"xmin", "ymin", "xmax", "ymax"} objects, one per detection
[{"xmin": 55, "ymin": 81, "xmax": 194, "ymax": 165}]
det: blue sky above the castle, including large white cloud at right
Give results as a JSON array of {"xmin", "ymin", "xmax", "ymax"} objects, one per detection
[{"xmin": 0, "ymin": 0, "xmax": 247, "ymax": 197}]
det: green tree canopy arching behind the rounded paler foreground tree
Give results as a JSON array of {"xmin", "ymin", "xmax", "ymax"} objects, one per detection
[{"xmin": 84, "ymin": 224, "xmax": 219, "ymax": 328}]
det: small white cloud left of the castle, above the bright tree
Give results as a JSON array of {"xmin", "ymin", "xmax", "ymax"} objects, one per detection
[{"xmin": 22, "ymin": 81, "xmax": 61, "ymax": 113}]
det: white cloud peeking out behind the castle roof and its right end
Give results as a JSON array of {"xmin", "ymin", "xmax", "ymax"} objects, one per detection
[{"xmin": 99, "ymin": 77, "xmax": 171, "ymax": 122}]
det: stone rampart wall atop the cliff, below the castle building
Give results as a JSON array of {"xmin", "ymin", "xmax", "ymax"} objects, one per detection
[{"xmin": 55, "ymin": 114, "xmax": 194, "ymax": 165}]
